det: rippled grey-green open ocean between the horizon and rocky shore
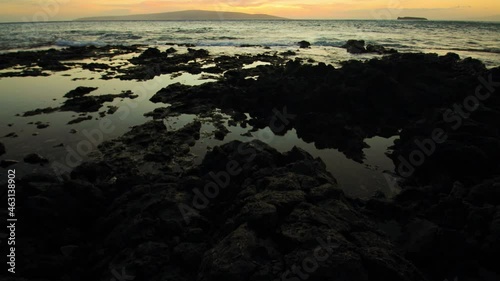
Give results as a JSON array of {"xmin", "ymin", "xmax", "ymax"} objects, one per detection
[{"xmin": 0, "ymin": 20, "xmax": 500, "ymax": 66}]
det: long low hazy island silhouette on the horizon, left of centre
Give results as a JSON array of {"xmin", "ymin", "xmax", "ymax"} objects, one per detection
[{"xmin": 75, "ymin": 10, "xmax": 286, "ymax": 21}]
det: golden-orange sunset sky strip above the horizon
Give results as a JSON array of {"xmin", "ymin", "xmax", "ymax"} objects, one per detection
[{"xmin": 0, "ymin": 0, "xmax": 500, "ymax": 22}]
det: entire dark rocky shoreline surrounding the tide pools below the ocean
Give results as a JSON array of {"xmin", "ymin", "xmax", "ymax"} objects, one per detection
[{"xmin": 0, "ymin": 44, "xmax": 500, "ymax": 281}]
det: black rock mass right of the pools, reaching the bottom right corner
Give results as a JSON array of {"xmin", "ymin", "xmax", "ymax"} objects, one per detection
[{"xmin": 147, "ymin": 54, "xmax": 500, "ymax": 280}]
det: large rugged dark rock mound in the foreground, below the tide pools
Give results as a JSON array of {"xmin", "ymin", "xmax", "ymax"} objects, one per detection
[{"xmin": 9, "ymin": 130, "xmax": 425, "ymax": 280}]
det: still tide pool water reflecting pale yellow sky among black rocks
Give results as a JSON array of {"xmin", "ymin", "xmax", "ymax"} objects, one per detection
[{"xmin": 0, "ymin": 58, "xmax": 394, "ymax": 197}]
